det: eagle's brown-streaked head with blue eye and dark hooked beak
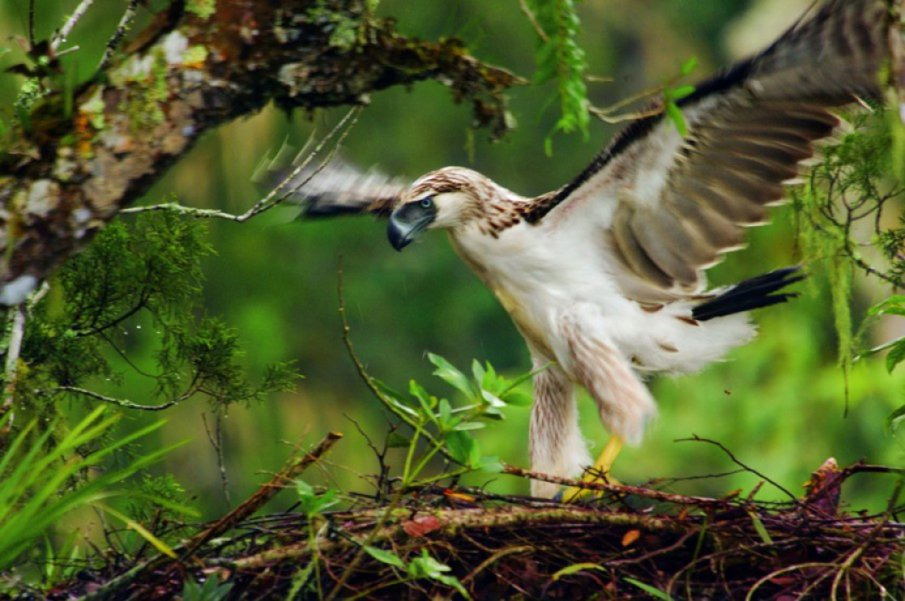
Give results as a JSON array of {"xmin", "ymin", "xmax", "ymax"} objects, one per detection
[{"xmin": 387, "ymin": 167, "xmax": 490, "ymax": 250}]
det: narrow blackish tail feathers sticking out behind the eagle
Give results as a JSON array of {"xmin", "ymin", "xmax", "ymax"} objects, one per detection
[{"xmin": 691, "ymin": 265, "xmax": 805, "ymax": 321}]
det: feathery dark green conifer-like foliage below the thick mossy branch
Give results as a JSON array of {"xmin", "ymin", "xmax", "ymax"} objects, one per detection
[{"xmin": 15, "ymin": 212, "xmax": 298, "ymax": 424}]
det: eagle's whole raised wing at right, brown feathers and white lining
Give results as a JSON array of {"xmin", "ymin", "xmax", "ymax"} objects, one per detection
[{"xmin": 528, "ymin": 0, "xmax": 901, "ymax": 301}]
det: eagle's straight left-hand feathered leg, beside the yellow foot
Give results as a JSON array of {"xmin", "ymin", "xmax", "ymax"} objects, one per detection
[{"xmin": 529, "ymin": 356, "xmax": 591, "ymax": 497}]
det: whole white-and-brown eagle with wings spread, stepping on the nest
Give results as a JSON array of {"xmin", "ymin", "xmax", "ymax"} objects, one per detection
[{"xmin": 301, "ymin": 0, "xmax": 902, "ymax": 496}]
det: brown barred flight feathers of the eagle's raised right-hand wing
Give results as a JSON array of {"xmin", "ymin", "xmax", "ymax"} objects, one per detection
[{"xmin": 604, "ymin": 0, "xmax": 890, "ymax": 289}]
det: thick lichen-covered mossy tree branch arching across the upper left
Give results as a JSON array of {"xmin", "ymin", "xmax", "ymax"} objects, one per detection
[{"xmin": 0, "ymin": 0, "xmax": 516, "ymax": 296}]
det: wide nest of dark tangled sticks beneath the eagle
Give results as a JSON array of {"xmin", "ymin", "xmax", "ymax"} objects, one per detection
[{"xmin": 37, "ymin": 435, "xmax": 905, "ymax": 600}]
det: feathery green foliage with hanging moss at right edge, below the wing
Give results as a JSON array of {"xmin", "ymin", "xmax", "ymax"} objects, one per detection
[{"xmin": 791, "ymin": 109, "xmax": 905, "ymax": 398}]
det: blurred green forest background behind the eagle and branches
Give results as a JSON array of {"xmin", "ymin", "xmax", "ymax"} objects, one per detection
[{"xmin": 0, "ymin": 0, "xmax": 905, "ymax": 517}]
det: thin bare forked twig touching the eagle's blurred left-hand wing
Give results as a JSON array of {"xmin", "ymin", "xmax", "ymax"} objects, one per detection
[{"xmin": 119, "ymin": 106, "xmax": 363, "ymax": 223}]
